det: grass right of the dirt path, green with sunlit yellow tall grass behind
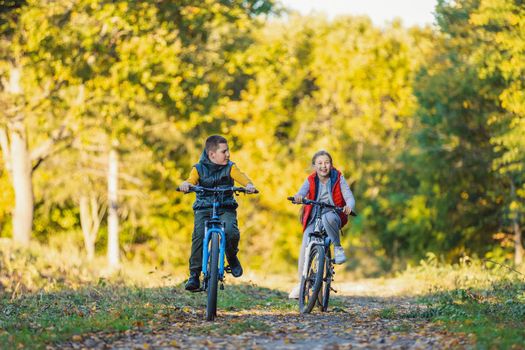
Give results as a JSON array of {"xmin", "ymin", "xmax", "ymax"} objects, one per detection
[{"xmin": 392, "ymin": 259, "xmax": 525, "ymax": 349}]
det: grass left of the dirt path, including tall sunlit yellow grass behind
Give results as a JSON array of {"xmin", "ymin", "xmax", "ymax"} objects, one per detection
[{"xmin": 0, "ymin": 241, "xmax": 296, "ymax": 349}]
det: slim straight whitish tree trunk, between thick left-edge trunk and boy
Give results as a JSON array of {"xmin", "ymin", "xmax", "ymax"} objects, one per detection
[{"xmin": 108, "ymin": 149, "xmax": 119, "ymax": 267}]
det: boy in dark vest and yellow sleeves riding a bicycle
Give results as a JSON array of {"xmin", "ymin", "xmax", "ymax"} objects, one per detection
[{"xmin": 179, "ymin": 135, "xmax": 256, "ymax": 291}]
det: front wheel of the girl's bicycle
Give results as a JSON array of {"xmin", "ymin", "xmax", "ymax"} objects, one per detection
[{"xmin": 299, "ymin": 245, "xmax": 325, "ymax": 314}]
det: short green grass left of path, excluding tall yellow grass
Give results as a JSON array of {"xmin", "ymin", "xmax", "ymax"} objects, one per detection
[{"xmin": 0, "ymin": 285, "xmax": 296, "ymax": 348}]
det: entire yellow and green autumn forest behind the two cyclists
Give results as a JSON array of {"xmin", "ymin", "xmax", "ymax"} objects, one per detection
[{"xmin": 0, "ymin": 0, "xmax": 525, "ymax": 276}]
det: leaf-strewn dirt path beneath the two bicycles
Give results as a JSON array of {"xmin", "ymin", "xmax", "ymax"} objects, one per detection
[{"xmin": 60, "ymin": 284, "xmax": 471, "ymax": 350}]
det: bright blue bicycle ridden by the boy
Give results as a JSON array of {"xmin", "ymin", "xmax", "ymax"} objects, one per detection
[{"xmin": 178, "ymin": 186, "xmax": 259, "ymax": 321}]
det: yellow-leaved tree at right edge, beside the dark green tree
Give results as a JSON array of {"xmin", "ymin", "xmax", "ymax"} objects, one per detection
[{"xmin": 470, "ymin": 0, "xmax": 525, "ymax": 264}]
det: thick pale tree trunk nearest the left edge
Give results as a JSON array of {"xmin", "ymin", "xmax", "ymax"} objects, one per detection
[{"xmin": 9, "ymin": 118, "xmax": 34, "ymax": 245}]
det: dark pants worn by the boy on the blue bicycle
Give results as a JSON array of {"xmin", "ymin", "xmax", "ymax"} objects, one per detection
[{"xmin": 190, "ymin": 209, "xmax": 241, "ymax": 273}]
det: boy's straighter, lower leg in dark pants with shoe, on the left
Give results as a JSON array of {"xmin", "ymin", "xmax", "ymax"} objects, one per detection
[{"xmin": 186, "ymin": 210, "xmax": 210, "ymax": 290}]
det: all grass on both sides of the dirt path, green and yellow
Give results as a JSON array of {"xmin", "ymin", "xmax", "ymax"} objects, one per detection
[{"xmin": 0, "ymin": 242, "xmax": 525, "ymax": 349}]
